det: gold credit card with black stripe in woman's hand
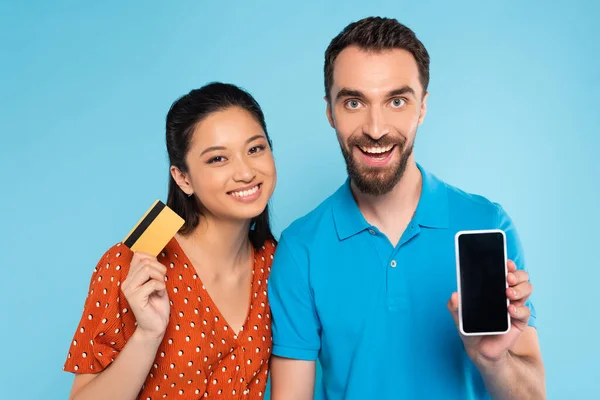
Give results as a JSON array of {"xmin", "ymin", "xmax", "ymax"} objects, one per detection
[{"xmin": 123, "ymin": 200, "xmax": 185, "ymax": 257}]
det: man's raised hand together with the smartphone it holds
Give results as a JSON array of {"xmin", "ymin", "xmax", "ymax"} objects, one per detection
[{"xmin": 447, "ymin": 229, "xmax": 533, "ymax": 366}]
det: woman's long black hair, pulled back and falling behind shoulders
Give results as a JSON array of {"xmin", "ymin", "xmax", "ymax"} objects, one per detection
[{"xmin": 166, "ymin": 82, "xmax": 274, "ymax": 248}]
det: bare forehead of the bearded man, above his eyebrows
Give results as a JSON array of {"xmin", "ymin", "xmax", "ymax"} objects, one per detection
[{"xmin": 332, "ymin": 47, "xmax": 420, "ymax": 94}]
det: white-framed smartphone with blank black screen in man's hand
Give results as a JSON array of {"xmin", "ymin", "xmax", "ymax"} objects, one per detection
[{"xmin": 455, "ymin": 229, "xmax": 510, "ymax": 336}]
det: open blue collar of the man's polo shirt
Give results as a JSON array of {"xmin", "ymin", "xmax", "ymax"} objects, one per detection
[{"xmin": 332, "ymin": 163, "xmax": 449, "ymax": 240}]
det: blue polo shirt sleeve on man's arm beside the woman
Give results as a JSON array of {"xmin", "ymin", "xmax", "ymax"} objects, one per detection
[{"xmin": 268, "ymin": 236, "xmax": 321, "ymax": 361}]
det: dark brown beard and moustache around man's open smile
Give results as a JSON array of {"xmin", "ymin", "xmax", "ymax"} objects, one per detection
[{"xmin": 340, "ymin": 135, "xmax": 414, "ymax": 196}]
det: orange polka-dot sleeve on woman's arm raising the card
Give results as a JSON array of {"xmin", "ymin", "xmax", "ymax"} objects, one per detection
[{"xmin": 63, "ymin": 244, "xmax": 135, "ymax": 374}]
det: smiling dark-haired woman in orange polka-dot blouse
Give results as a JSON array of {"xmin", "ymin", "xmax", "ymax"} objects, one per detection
[{"xmin": 64, "ymin": 83, "xmax": 276, "ymax": 400}]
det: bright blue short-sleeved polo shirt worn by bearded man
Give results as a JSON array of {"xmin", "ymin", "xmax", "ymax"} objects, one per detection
[{"xmin": 269, "ymin": 165, "xmax": 536, "ymax": 400}]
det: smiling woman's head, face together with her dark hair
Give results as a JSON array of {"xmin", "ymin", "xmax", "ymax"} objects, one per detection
[{"xmin": 167, "ymin": 83, "xmax": 275, "ymax": 245}]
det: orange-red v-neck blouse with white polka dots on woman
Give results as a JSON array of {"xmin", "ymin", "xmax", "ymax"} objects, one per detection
[{"xmin": 63, "ymin": 238, "xmax": 276, "ymax": 399}]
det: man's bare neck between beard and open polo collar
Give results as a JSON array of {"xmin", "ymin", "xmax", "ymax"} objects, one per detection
[{"xmin": 351, "ymin": 160, "xmax": 423, "ymax": 246}]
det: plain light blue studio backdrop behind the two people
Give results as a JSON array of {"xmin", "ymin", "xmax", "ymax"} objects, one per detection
[{"xmin": 0, "ymin": 0, "xmax": 600, "ymax": 399}]
